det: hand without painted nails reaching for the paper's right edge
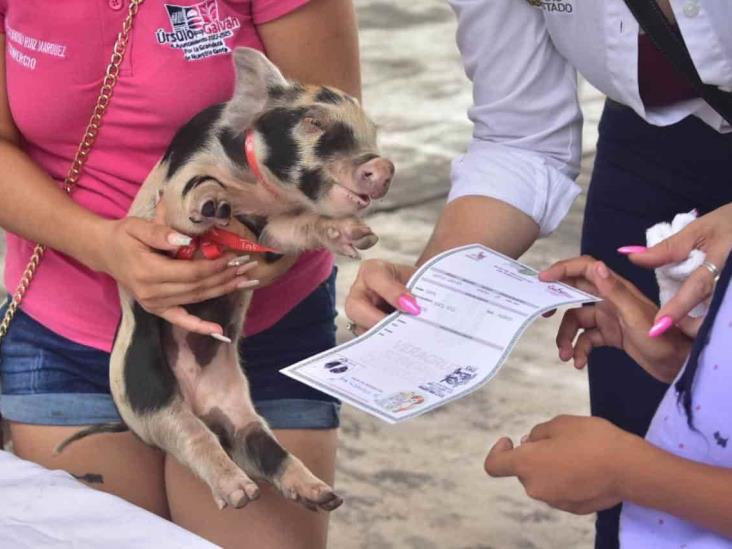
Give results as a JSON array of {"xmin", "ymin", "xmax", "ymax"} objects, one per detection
[{"xmin": 539, "ymin": 256, "xmax": 691, "ymax": 383}]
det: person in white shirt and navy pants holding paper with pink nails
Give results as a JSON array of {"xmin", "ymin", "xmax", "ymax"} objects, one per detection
[{"xmin": 346, "ymin": 0, "xmax": 732, "ymax": 549}]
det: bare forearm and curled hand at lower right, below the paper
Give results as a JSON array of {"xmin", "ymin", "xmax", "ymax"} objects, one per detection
[{"xmin": 485, "ymin": 416, "xmax": 732, "ymax": 538}]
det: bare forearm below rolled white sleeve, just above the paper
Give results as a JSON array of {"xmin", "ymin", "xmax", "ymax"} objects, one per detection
[{"xmin": 418, "ymin": 196, "xmax": 539, "ymax": 264}]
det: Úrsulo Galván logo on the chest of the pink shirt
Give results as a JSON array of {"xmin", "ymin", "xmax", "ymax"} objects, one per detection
[{"xmin": 155, "ymin": 0, "xmax": 241, "ymax": 61}]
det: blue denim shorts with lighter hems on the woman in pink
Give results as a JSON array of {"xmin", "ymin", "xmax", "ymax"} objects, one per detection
[{"xmin": 0, "ymin": 270, "xmax": 340, "ymax": 429}]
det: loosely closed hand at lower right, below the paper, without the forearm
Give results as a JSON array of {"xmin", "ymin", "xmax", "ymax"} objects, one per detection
[{"xmin": 485, "ymin": 416, "xmax": 643, "ymax": 514}]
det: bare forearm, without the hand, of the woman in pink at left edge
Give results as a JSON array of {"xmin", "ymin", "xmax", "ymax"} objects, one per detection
[{"xmin": 0, "ymin": 140, "xmax": 105, "ymax": 268}]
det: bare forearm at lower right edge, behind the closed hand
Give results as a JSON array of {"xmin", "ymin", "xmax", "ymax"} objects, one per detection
[{"xmin": 620, "ymin": 439, "xmax": 732, "ymax": 538}]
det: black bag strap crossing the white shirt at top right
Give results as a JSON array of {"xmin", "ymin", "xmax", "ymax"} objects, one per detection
[{"xmin": 625, "ymin": 0, "xmax": 732, "ymax": 125}]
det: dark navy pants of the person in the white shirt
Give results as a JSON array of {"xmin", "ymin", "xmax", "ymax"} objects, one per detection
[{"xmin": 582, "ymin": 101, "xmax": 732, "ymax": 549}]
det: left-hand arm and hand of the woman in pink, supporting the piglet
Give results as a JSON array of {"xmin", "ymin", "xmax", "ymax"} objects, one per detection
[{"xmin": 0, "ymin": 34, "xmax": 252, "ymax": 334}]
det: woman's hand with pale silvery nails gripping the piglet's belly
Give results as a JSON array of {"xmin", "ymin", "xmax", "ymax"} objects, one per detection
[{"xmin": 94, "ymin": 217, "xmax": 258, "ymax": 335}]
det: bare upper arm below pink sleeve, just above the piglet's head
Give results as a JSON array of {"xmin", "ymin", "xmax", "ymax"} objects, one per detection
[{"xmin": 258, "ymin": 0, "xmax": 361, "ymax": 99}]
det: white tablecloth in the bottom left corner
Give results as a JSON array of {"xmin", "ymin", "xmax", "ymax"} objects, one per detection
[{"xmin": 0, "ymin": 451, "xmax": 216, "ymax": 549}]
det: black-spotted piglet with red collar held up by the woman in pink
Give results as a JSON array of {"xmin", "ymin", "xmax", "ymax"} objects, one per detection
[{"xmin": 59, "ymin": 48, "xmax": 394, "ymax": 510}]
